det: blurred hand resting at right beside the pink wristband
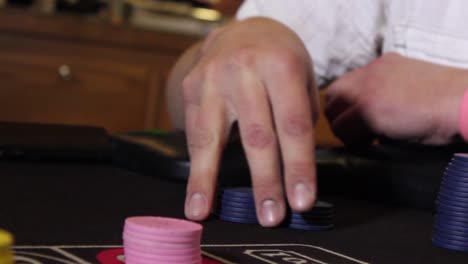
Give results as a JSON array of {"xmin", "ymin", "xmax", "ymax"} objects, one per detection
[{"xmin": 326, "ymin": 54, "xmax": 468, "ymax": 144}]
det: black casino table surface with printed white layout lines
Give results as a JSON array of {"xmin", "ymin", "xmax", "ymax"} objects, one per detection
[{"xmin": 0, "ymin": 122, "xmax": 468, "ymax": 264}]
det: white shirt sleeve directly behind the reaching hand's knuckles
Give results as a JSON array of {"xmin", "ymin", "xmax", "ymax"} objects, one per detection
[{"xmin": 237, "ymin": 0, "xmax": 384, "ymax": 86}]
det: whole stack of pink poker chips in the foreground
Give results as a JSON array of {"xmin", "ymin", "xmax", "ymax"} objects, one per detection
[{"xmin": 123, "ymin": 216, "xmax": 203, "ymax": 264}]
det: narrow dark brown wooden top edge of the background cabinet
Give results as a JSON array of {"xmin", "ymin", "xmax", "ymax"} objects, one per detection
[{"xmin": 0, "ymin": 8, "xmax": 196, "ymax": 53}]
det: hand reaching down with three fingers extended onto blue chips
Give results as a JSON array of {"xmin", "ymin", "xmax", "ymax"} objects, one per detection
[{"xmin": 182, "ymin": 18, "xmax": 318, "ymax": 226}]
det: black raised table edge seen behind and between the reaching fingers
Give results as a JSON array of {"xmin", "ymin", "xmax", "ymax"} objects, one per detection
[{"xmin": 111, "ymin": 131, "xmax": 468, "ymax": 209}]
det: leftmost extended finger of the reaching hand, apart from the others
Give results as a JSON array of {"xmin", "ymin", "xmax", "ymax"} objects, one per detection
[{"xmin": 185, "ymin": 78, "xmax": 227, "ymax": 220}]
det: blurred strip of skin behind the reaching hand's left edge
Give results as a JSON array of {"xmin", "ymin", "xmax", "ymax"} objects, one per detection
[{"xmin": 166, "ymin": 42, "xmax": 201, "ymax": 129}]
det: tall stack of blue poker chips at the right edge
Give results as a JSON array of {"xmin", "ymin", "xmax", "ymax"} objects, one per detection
[{"xmin": 432, "ymin": 153, "xmax": 468, "ymax": 252}]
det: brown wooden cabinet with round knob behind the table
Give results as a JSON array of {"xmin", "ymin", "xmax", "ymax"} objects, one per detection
[{"xmin": 0, "ymin": 9, "xmax": 197, "ymax": 133}]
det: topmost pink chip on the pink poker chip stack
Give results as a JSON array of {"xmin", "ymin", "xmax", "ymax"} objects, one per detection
[{"xmin": 125, "ymin": 216, "xmax": 203, "ymax": 237}]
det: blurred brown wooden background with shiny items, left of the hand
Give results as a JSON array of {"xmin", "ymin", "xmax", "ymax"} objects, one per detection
[{"xmin": 0, "ymin": 0, "xmax": 336, "ymax": 145}]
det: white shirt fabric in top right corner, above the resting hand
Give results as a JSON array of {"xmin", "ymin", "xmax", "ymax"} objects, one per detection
[{"xmin": 383, "ymin": 0, "xmax": 468, "ymax": 69}]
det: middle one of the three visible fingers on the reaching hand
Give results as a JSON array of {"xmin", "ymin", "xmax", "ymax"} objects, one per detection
[{"xmin": 231, "ymin": 69, "xmax": 286, "ymax": 227}]
